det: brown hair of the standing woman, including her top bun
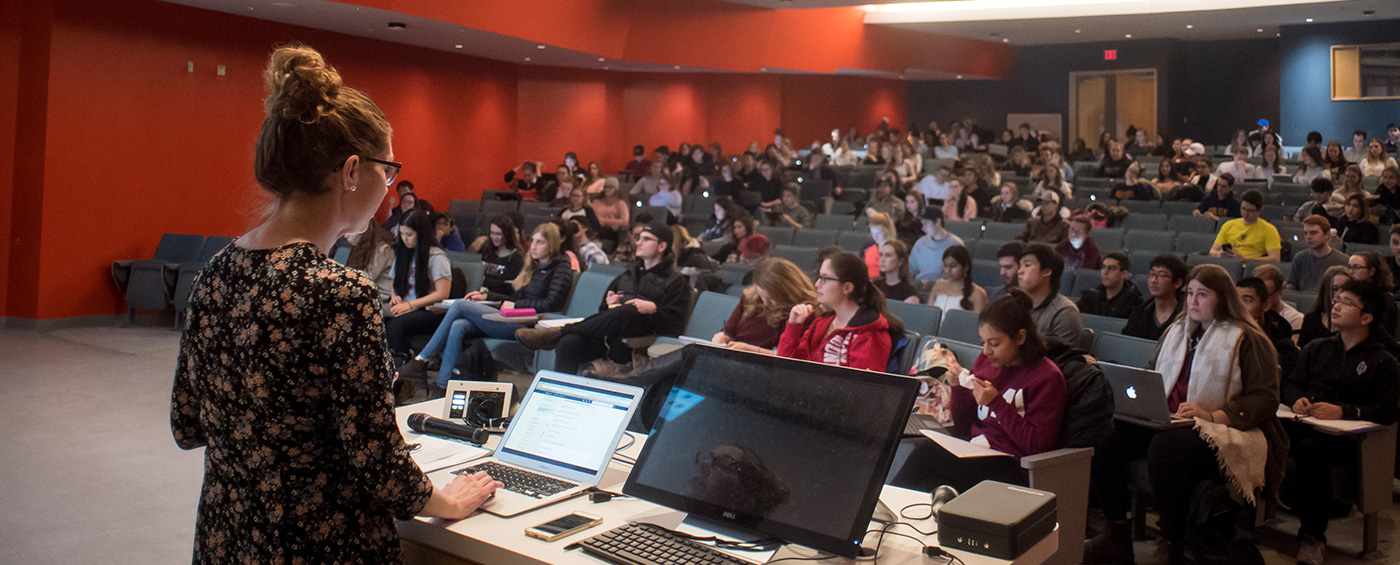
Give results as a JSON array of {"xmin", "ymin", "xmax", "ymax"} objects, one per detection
[{"xmin": 253, "ymin": 45, "xmax": 393, "ymax": 199}]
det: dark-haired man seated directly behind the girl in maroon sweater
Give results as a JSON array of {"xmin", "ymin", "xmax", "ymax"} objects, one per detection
[{"xmin": 1016, "ymin": 243, "xmax": 1084, "ymax": 344}]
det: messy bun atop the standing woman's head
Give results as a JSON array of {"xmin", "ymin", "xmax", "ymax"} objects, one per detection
[{"xmin": 263, "ymin": 45, "xmax": 342, "ymax": 123}]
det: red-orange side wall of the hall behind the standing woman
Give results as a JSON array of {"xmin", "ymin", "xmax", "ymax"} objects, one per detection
[{"xmin": 10, "ymin": 0, "xmax": 906, "ymax": 319}]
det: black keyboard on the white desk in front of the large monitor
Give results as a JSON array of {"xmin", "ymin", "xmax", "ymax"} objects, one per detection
[{"xmin": 578, "ymin": 522, "xmax": 753, "ymax": 565}]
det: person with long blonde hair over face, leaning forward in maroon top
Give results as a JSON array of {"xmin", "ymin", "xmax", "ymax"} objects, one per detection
[{"xmin": 711, "ymin": 257, "xmax": 818, "ymax": 354}]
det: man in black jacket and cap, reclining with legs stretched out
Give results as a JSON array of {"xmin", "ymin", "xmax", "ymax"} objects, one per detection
[{"xmin": 515, "ymin": 221, "xmax": 690, "ymax": 375}]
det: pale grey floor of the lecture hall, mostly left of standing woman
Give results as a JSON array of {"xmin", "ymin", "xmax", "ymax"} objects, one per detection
[{"xmin": 0, "ymin": 327, "xmax": 1400, "ymax": 565}]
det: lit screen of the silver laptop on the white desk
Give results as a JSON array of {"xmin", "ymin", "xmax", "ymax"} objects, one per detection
[{"xmin": 497, "ymin": 372, "xmax": 636, "ymax": 475}]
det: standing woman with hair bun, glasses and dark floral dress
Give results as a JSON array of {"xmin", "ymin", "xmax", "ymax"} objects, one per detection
[{"xmin": 171, "ymin": 46, "xmax": 500, "ymax": 564}]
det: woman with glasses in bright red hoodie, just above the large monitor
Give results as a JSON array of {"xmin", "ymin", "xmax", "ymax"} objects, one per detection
[{"xmin": 778, "ymin": 253, "xmax": 904, "ymax": 371}]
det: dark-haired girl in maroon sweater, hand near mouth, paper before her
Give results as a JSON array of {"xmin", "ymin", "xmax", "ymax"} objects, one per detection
[{"xmin": 890, "ymin": 289, "xmax": 1065, "ymax": 491}]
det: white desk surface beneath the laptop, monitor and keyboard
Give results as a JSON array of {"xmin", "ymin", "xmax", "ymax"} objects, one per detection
[{"xmin": 398, "ymin": 399, "xmax": 1058, "ymax": 565}]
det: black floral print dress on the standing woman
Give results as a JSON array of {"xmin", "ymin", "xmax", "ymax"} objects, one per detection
[{"xmin": 171, "ymin": 243, "xmax": 433, "ymax": 564}]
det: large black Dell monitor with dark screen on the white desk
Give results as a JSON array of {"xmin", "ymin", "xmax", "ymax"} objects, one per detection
[{"xmin": 623, "ymin": 345, "xmax": 918, "ymax": 557}]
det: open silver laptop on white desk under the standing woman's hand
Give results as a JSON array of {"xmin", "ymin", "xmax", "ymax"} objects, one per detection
[{"xmin": 436, "ymin": 371, "xmax": 643, "ymax": 516}]
